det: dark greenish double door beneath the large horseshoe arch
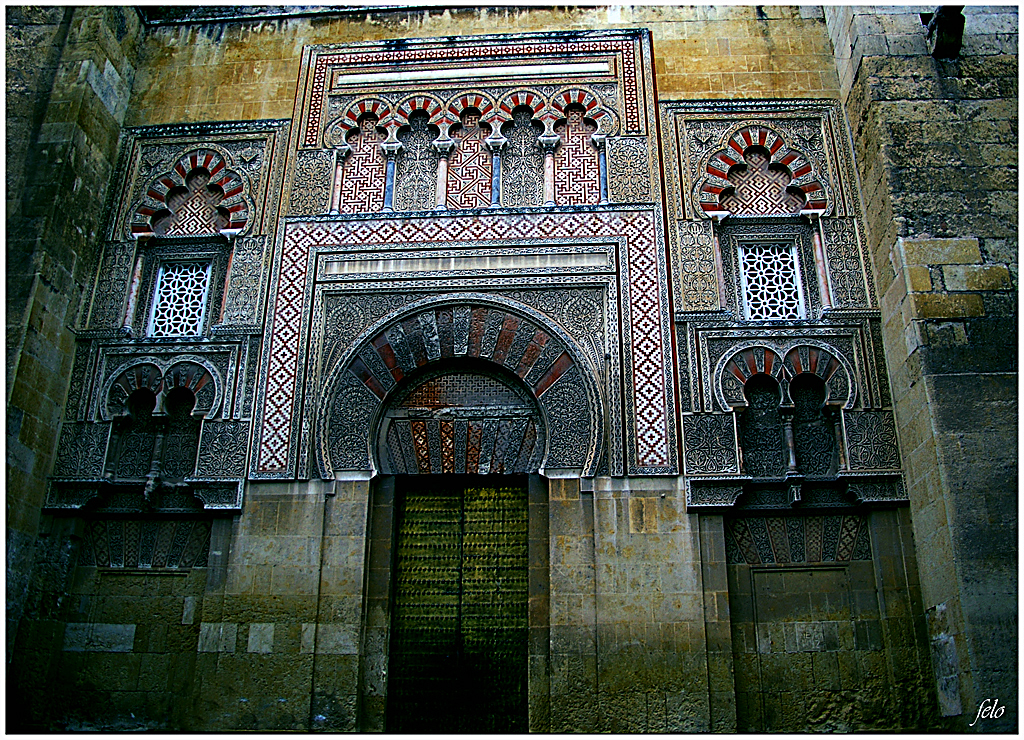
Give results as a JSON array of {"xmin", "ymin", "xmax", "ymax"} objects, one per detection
[{"xmin": 386, "ymin": 475, "xmax": 528, "ymax": 733}]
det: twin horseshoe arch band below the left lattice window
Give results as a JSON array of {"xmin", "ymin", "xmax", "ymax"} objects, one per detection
[{"xmin": 99, "ymin": 356, "xmax": 223, "ymax": 421}]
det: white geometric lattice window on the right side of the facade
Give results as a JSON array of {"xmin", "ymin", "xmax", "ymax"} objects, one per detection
[{"xmin": 739, "ymin": 242, "xmax": 804, "ymax": 320}]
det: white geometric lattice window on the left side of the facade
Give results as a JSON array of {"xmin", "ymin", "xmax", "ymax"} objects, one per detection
[{"xmin": 148, "ymin": 262, "xmax": 211, "ymax": 337}]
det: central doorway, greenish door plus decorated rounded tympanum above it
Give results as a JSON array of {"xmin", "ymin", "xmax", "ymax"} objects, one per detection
[{"xmin": 377, "ymin": 359, "xmax": 545, "ymax": 733}]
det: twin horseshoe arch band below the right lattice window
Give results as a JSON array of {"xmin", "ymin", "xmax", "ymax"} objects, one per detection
[{"xmin": 714, "ymin": 344, "xmax": 857, "ymax": 409}]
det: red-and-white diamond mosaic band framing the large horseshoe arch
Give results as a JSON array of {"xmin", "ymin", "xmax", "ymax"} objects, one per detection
[{"xmin": 257, "ymin": 211, "xmax": 671, "ymax": 472}]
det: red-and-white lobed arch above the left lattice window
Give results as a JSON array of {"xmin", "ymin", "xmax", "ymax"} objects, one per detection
[{"xmin": 129, "ymin": 146, "xmax": 253, "ymax": 236}]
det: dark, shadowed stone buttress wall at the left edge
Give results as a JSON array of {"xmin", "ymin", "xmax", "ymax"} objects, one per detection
[{"xmin": 6, "ymin": 7, "xmax": 141, "ymax": 658}]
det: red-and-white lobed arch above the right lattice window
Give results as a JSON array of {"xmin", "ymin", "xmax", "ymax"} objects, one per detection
[{"xmin": 694, "ymin": 124, "xmax": 831, "ymax": 218}]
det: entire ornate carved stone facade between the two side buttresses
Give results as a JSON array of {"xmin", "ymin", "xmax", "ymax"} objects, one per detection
[{"xmin": 11, "ymin": 8, "xmax": 1011, "ymax": 732}]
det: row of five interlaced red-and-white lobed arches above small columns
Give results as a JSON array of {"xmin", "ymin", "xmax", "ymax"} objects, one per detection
[{"xmin": 324, "ymin": 87, "xmax": 618, "ymax": 154}]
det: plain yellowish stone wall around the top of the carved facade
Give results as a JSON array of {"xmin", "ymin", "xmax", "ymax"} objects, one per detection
[{"xmin": 126, "ymin": 6, "xmax": 839, "ymax": 126}]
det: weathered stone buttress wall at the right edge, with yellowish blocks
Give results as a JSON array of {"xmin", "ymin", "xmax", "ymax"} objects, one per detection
[{"xmin": 825, "ymin": 7, "xmax": 1018, "ymax": 732}]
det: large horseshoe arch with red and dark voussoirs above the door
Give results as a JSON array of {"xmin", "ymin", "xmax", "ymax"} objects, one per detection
[{"xmin": 314, "ymin": 296, "xmax": 602, "ymax": 478}]
